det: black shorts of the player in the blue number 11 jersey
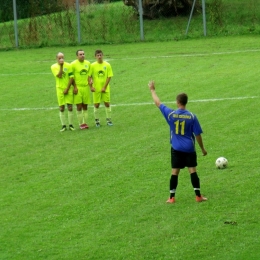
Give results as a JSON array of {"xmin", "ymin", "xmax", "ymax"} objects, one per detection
[{"xmin": 171, "ymin": 147, "xmax": 197, "ymax": 169}]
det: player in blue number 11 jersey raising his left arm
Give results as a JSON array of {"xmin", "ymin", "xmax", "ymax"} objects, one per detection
[{"xmin": 148, "ymin": 81, "xmax": 207, "ymax": 203}]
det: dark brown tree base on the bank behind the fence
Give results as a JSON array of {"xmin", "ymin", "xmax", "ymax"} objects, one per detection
[{"xmin": 123, "ymin": 0, "xmax": 201, "ymax": 19}]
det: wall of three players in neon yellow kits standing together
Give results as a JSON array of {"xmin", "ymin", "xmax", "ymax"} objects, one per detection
[{"xmin": 51, "ymin": 50, "xmax": 113, "ymax": 132}]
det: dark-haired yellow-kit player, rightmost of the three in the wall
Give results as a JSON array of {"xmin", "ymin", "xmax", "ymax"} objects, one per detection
[{"xmin": 89, "ymin": 50, "xmax": 113, "ymax": 127}]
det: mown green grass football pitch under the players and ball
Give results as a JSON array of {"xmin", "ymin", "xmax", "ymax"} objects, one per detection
[{"xmin": 0, "ymin": 36, "xmax": 260, "ymax": 260}]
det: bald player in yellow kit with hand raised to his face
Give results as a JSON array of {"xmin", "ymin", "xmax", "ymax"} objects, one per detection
[{"xmin": 51, "ymin": 52, "xmax": 75, "ymax": 132}]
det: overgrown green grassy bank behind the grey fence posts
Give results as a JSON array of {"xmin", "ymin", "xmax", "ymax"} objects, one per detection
[{"xmin": 0, "ymin": 0, "xmax": 260, "ymax": 50}]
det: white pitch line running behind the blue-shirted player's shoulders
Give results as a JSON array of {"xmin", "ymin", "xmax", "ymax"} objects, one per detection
[{"xmin": 0, "ymin": 96, "xmax": 259, "ymax": 111}]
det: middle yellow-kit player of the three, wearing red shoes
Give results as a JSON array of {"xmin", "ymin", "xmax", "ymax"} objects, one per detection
[{"xmin": 71, "ymin": 50, "xmax": 91, "ymax": 129}]
